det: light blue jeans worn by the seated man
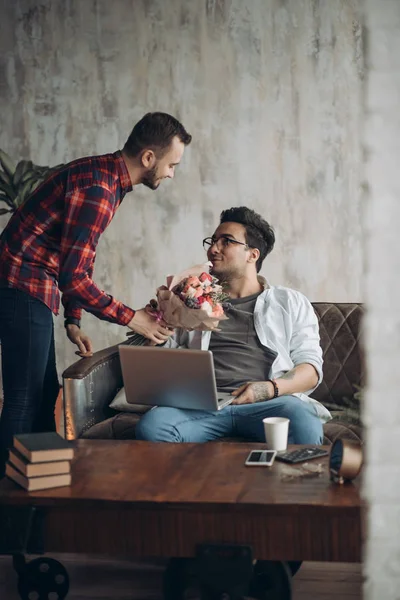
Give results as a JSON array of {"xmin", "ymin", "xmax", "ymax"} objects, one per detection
[{"xmin": 136, "ymin": 396, "xmax": 323, "ymax": 444}]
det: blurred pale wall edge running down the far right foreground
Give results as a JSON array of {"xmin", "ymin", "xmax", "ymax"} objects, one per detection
[{"xmin": 364, "ymin": 0, "xmax": 400, "ymax": 600}]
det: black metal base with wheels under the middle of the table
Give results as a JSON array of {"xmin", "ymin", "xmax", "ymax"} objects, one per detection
[{"xmin": 164, "ymin": 545, "xmax": 292, "ymax": 600}]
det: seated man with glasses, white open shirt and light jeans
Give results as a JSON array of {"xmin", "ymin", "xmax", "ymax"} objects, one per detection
[{"xmin": 136, "ymin": 207, "xmax": 330, "ymax": 444}]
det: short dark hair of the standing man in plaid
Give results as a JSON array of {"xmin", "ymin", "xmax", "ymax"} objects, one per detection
[{"xmin": 124, "ymin": 112, "xmax": 192, "ymax": 158}]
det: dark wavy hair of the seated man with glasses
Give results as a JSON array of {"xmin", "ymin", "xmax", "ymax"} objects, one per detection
[{"xmin": 220, "ymin": 206, "xmax": 275, "ymax": 273}]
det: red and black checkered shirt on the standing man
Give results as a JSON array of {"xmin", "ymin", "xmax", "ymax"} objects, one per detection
[{"xmin": 0, "ymin": 151, "xmax": 135, "ymax": 325}]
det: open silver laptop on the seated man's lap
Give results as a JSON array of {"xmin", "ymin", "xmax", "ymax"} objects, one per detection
[{"xmin": 119, "ymin": 346, "xmax": 233, "ymax": 410}]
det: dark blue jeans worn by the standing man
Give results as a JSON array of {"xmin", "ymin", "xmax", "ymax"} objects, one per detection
[{"xmin": 0, "ymin": 287, "xmax": 60, "ymax": 457}]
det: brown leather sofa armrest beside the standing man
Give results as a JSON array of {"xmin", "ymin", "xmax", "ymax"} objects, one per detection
[{"xmin": 62, "ymin": 335, "xmax": 144, "ymax": 440}]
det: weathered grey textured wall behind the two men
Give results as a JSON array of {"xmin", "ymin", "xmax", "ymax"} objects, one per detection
[{"xmin": 0, "ymin": 0, "xmax": 363, "ymax": 376}]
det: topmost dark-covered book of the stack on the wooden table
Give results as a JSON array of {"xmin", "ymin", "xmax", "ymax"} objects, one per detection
[{"xmin": 14, "ymin": 431, "xmax": 74, "ymax": 463}]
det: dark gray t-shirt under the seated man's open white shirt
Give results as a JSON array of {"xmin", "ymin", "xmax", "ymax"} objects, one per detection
[{"xmin": 209, "ymin": 292, "xmax": 277, "ymax": 392}]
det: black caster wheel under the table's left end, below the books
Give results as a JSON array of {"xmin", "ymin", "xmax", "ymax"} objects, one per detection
[{"xmin": 18, "ymin": 557, "xmax": 69, "ymax": 600}]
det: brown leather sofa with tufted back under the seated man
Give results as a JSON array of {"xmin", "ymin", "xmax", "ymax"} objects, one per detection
[{"xmin": 63, "ymin": 302, "xmax": 364, "ymax": 444}]
